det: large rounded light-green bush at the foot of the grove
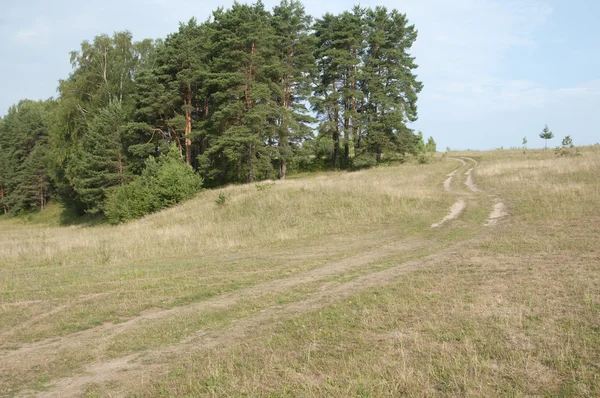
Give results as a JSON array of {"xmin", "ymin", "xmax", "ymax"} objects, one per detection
[{"xmin": 104, "ymin": 146, "xmax": 202, "ymax": 224}]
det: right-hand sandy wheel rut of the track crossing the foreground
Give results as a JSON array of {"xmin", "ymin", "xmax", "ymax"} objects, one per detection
[{"xmin": 30, "ymin": 241, "xmax": 472, "ymax": 398}]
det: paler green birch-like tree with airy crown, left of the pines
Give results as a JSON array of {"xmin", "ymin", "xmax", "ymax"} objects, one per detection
[{"xmin": 49, "ymin": 31, "xmax": 153, "ymax": 211}]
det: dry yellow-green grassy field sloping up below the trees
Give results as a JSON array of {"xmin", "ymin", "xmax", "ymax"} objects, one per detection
[{"xmin": 0, "ymin": 147, "xmax": 600, "ymax": 397}]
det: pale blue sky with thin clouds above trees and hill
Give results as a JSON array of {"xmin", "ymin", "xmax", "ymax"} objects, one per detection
[{"xmin": 0, "ymin": 0, "xmax": 600, "ymax": 150}]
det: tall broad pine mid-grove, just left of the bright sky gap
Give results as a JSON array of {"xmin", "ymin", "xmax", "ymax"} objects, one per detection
[{"xmin": 201, "ymin": 1, "xmax": 281, "ymax": 183}]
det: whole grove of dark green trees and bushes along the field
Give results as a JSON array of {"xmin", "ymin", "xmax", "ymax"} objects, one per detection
[{"xmin": 0, "ymin": 0, "xmax": 435, "ymax": 222}]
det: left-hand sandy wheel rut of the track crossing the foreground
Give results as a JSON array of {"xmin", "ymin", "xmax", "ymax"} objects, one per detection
[{"xmin": 7, "ymin": 239, "xmax": 433, "ymax": 396}]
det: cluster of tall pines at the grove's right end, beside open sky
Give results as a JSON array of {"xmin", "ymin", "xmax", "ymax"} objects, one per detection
[{"xmin": 312, "ymin": 6, "xmax": 422, "ymax": 168}]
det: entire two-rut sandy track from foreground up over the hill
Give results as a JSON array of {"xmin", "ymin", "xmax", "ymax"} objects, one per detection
[{"xmin": 11, "ymin": 158, "xmax": 505, "ymax": 397}]
